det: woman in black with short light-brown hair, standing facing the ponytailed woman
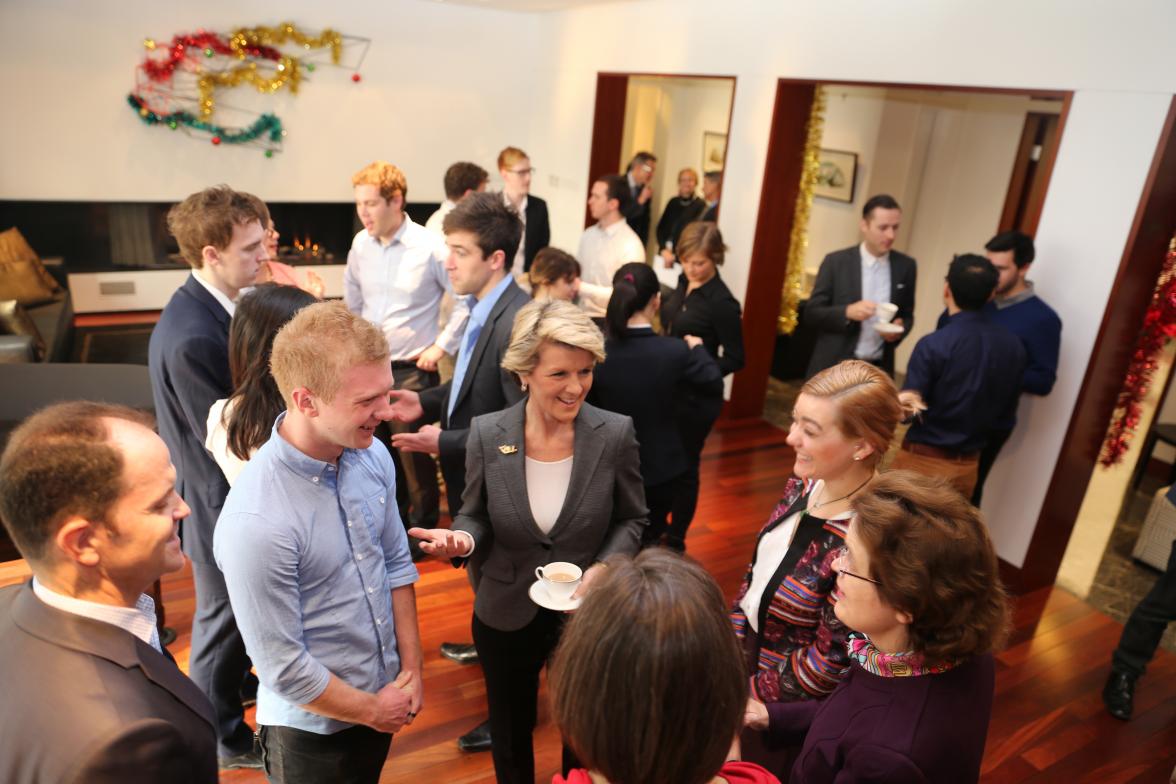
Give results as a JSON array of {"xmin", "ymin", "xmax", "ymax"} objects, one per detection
[{"xmin": 661, "ymin": 221, "xmax": 743, "ymax": 550}]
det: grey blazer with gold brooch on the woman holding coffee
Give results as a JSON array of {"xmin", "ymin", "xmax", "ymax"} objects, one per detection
[{"xmin": 453, "ymin": 400, "xmax": 649, "ymax": 631}]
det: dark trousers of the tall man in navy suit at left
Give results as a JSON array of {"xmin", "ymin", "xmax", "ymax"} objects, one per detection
[{"xmin": 188, "ymin": 561, "xmax": 253, "ymax": 757}]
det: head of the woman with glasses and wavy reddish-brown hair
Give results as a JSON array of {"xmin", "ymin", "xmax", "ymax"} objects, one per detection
[{"xmin": 834, "ymin": 471, "xmax": 1009, "ymax": 665}]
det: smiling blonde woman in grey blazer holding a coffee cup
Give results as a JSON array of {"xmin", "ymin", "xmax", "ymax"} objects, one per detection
[{"xmin": 409, "ymin": 300, "xmax": 648, "ymax": 784}]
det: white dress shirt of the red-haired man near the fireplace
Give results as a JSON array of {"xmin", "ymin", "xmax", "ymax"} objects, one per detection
[{"xmin": 343, "ymin": 215, "xmax": 469, "ymax": 362}]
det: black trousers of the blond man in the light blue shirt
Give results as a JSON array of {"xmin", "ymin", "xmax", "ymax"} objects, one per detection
[{"xmin": 258, "ymin": 725, "xmax": 392, "ymax": 784}]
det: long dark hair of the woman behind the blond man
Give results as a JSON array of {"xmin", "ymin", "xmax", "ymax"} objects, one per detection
[{"xmin": 226, "ymin": 283, "xmax": 318, "ymax": 460}]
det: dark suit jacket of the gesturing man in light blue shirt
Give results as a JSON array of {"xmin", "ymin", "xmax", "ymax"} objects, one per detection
[{"xmin": 421, "ymin": 281, "xmax": 530, "ymax": 516}]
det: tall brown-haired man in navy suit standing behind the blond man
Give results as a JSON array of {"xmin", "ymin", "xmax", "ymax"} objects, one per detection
[{"xmin": 147, "ymin": 186, "xmax": 268, "ymax": 768}]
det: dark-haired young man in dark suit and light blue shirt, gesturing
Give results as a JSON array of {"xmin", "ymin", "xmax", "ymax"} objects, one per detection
[{"xmin": 392, "ymin": 194, "xmax": 529, "ymax": 751}]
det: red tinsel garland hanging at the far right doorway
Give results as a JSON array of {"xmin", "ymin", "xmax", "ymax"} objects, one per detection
[{"xmin": 1098, "ymin": 236, "xmax": 1176, "ymax": 468}]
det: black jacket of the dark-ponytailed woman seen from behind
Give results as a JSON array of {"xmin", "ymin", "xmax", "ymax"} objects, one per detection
[{"xmin": 588, "ymin": 329, "xmax": 723, "ymax": 487}]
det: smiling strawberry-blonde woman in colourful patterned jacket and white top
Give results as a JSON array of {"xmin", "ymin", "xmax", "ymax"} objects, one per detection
[{"xmin": 731, "ymin": 360, "xmax": 904, "ymax": 778}]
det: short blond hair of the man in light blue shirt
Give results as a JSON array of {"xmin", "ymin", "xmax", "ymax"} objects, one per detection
[{"xmin": 269, "ymin": 300, "xmax": 389, "ymax": 407}]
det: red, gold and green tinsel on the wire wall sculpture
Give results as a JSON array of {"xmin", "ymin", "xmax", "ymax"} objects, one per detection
[{"xmin": 127, "ymin": 22, "xmax": 372, "ymax": 158}]
